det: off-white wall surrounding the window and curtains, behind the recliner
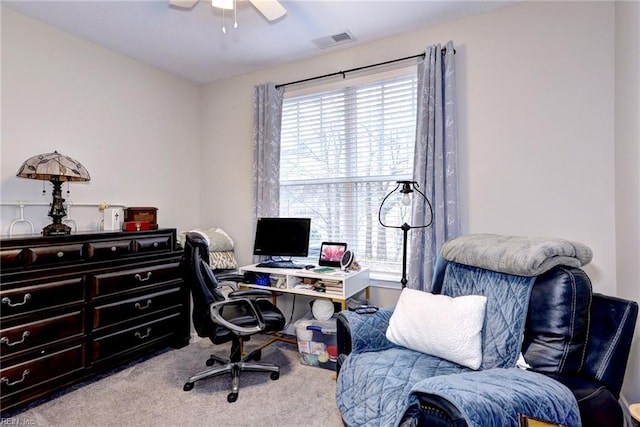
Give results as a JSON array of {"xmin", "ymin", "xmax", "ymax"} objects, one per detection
[{"xmin": 202, "ymin": 2, "xmax": 616, "ymax": 293}]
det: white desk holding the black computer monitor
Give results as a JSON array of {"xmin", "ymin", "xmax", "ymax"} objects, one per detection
[{"xmin": 240, "ymin": 264, "xmax": 369, "ymax": 310}]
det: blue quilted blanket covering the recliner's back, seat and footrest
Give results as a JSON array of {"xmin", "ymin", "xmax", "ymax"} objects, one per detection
[{"xmin": 336, "ymin": 262, "xmax": 579, "ymax": 427}]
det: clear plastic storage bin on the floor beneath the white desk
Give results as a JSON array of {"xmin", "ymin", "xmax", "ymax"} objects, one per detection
[{"xmin": 294, "ymin": 317, "xmax": 338, "ymax": 371}]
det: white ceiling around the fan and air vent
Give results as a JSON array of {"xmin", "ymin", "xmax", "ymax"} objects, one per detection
[{"xmin": 2, "ymin": 0, "xmax": 513, "ymax": 83}]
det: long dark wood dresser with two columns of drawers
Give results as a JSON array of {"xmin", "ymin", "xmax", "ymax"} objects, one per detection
[{"xmin": 0, "ymin": 229, "xmax": 190, "ymax": 412}]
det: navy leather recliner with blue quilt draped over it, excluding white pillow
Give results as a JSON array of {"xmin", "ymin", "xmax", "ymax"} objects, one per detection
[{"xmin": 337, "ymin": 236, "xmax": 638, "ymax": 427}]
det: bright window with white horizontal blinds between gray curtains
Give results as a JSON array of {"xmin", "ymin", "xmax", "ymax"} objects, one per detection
[{"xmin": 280, "ymin": 68, "xmax": 417, "ymax": 274}]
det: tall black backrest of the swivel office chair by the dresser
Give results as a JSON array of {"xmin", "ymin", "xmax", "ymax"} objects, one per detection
[{"xmin": 184, "ymin": 232, "xmax": 225, "ymax": 337}]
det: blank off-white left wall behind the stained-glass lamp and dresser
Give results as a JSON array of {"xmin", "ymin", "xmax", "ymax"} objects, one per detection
[{"xmin": 0, "ymin": 8, "xmax": 201, "ymax": 234}]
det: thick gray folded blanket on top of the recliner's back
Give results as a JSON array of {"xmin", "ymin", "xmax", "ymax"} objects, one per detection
[{"xmin": 442, "ymin": 234, "xmax": 593, "ymax": 277}]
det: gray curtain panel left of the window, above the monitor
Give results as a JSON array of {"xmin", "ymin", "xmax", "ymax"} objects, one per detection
[{"xmin": 253, "ymin": 83, "xmax": 284, "ymax": 218}]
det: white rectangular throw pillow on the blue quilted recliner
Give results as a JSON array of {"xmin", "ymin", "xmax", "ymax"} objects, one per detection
[{"xmin": 386, "ymin": 288, "xmax": 487, "ymax": 369}]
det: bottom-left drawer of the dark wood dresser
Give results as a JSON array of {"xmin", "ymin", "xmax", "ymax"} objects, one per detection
[{"xmin": 0, "ymin": 345, "xmax": 84, "ymax": 400}]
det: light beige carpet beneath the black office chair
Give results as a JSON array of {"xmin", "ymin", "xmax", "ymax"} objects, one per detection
[{"xmin": 5, "ymin": 337, "xmax": 342, "ymax": 427}]
